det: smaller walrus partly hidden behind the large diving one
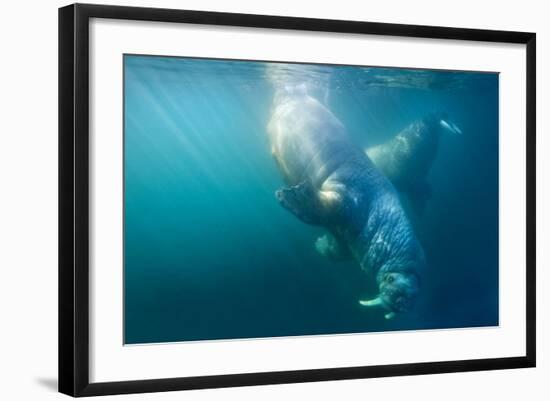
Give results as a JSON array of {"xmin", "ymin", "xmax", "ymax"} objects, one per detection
[{"xmin": 366, "ymin": 113, "xmax": 462, "ymax": 215}]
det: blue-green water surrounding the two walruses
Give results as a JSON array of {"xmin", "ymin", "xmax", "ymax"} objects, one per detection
[{"xmin": 124, "ymin": 55, "xmax": 498, "ymax": 344}]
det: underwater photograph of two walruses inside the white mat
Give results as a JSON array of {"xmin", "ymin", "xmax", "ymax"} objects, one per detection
[{"xmin": 124, "ymin": 55, "xmax": 499, "ymax": 344}]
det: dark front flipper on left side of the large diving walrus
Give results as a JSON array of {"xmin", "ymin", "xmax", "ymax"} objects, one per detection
[{"xmin": 275, "ymin": 181, "xmax": 324, "ymax": 225}]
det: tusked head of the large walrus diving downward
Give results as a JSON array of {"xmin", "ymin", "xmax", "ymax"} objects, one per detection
[{"xmin": 359, "ymin": 271, "xmax": 419, "ymax": 319}]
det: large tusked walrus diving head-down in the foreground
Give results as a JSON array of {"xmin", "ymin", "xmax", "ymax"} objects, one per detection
[{"xmin": 267, "ymin": 79, "xmax": 426, "ymax": 319}]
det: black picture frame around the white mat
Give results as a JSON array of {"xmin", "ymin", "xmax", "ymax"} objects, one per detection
[{"xmin": 59, "ymin": 4, "xmax": 536, "ymax": 396}]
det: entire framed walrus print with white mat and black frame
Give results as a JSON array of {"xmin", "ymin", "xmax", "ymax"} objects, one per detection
[{"xmin": 59, "ymin": 4, "xmax": 536, "ymax": 396}]
